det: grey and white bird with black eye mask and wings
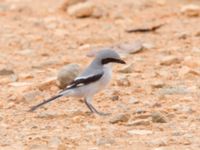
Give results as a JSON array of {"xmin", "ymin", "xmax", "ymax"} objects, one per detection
[{"xmin": 29, "ymin": 48, "xmax": 126, "ymax": 115}]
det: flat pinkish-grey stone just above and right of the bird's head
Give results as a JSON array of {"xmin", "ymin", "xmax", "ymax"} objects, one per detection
[{"xmin": 118, "ymin": 41, "xmax": 144, "ymax": 54}]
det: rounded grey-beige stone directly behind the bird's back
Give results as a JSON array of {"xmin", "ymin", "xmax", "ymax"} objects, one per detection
[{"xmin": 57, "ymin": 64, "xmax": 81, "ymax": 89}]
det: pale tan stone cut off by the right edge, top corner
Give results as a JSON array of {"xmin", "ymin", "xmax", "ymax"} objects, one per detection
[{"xmin": 181, "ymin": 4, "xmax": 200, "ymax": 17}]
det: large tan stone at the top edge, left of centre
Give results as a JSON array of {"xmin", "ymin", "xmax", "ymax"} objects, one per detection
[{"xmin": 67, "ymin": 2, "xmax": 95, "ymax": 18}]
